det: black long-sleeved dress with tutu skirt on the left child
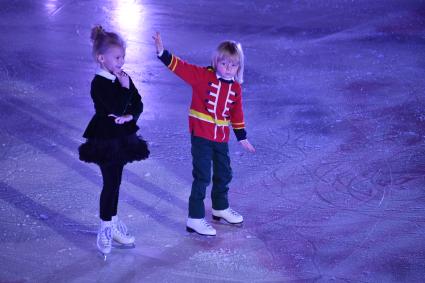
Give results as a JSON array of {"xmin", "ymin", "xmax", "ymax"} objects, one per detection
[{"xmin": 78, "ymin": 75, "xmax": 149, "ymax": 165}]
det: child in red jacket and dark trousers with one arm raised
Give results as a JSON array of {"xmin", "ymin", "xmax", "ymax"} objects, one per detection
[{"xmin": 153, "ymin": 33, "xmax": 255, "ymax": 236}]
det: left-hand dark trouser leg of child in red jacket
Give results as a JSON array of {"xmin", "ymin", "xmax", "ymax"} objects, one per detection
[{"xmin": 189, "ymin": 136, "xmax": 212, "ymax": 219}]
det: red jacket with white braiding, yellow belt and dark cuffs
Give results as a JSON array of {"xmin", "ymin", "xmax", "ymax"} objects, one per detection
[{"xmin": 159, "ymin": 50, "xmax": 246, "ymax": 142}]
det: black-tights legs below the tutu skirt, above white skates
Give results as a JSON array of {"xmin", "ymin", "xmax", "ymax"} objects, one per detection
[{"xmin": 100, "ymin": 163, "xmax": 122, "ymax": 221}]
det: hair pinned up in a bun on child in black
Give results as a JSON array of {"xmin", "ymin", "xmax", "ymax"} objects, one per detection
[{"xmin": 90, "ymin": 25, "xmax": 126, "ymax": 62}]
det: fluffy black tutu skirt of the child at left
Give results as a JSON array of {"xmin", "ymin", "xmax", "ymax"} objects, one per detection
[{"xmin": 78, "ymin": 134, "xmax": 150, "ymax": 165}]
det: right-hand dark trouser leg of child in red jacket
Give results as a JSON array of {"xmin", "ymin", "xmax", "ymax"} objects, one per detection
[{"xmin": 211, "ymin": 143, "xmax": 232, "ymax": 210}]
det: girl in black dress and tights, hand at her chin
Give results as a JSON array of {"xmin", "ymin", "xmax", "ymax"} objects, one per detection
[{"xmin": 79, "ymin": 26, "xmax": 149, "ymax": 256}]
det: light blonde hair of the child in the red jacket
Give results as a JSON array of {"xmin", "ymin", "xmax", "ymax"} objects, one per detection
[{"xmin": 212, "ymin": 40, "xmax": 244, "ymax": 84}]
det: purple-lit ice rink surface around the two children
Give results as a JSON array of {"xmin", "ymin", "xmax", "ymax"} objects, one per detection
[{"xmin": 0, "ymin": 0, "xmax": 425, "ymax": 282}]
